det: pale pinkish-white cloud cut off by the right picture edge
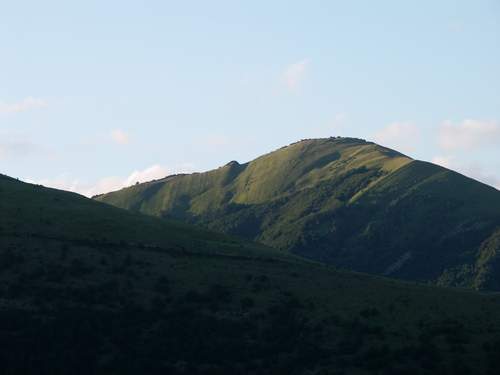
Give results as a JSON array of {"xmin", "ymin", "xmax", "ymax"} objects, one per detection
[{"xmin": 439, "ymin": 119, "xmax": 500, "ymax": 151}]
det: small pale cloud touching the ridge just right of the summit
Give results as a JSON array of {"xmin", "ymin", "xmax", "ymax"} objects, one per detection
[{"xmin": 374, "ymin": 122, "xmax": 420, "ymax": 152}]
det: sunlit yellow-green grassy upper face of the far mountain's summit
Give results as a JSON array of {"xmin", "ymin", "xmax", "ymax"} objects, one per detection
[{"xmin": 232, "ymin": 139, "xmax": 412, "ymax": 204}]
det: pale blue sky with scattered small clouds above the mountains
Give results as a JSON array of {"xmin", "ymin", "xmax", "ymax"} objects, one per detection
[{"xmin": 0, "ymin": 0, "xmax": 500, "ymax": 194}]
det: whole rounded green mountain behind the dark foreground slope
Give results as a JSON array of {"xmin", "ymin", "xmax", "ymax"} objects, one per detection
[{"xmin": 96, "ymin": 138, "xmax": 500, "ymax": 290}]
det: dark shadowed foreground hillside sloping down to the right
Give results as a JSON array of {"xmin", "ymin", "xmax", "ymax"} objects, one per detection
[{"xmin": 0, "ymin": 176, "xmax": 500, "ymax": 375}]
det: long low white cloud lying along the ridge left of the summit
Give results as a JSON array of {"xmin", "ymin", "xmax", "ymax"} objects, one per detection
[{"xmin": 26, "ymin": 163, "xmax": 193, "ymax": 197}]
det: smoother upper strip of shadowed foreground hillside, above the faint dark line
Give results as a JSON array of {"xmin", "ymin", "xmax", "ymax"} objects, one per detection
[{"xmin": 0, "ymin": 175, "xmax": 283, "ymax": 257}]
